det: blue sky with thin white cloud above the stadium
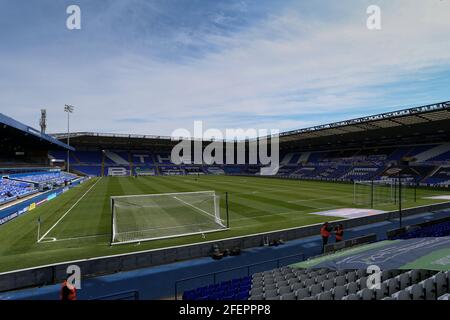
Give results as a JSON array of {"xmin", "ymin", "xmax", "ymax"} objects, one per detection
[{"xmin": 0, "ymin": 0, "xmax": 450, "ymax": 135}]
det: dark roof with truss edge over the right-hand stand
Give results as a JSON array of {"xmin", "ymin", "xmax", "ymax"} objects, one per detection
[{"xmin": 280, "ymin": 101, "xmax": 450, "ymax": 150}]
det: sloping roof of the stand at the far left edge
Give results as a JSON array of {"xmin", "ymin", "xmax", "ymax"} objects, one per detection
[{"xmin": 0, "ymin": 113, "xmax": 75, "ymax": 151}]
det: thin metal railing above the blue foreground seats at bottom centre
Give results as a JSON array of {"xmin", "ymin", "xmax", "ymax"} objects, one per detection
[{"xmin": 174, "ymin": 253, "xmax": 305, "ymax": 300}]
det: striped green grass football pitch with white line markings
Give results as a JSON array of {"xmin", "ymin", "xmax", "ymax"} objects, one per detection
[{"xmin": 0, "ymin": 176, "xmax": 442, "ymax": 272}]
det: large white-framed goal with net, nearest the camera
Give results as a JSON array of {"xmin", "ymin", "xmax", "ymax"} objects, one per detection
[{"xmin": 111, "ymin": 191, "xmax": 229, "ymax": 245}]
